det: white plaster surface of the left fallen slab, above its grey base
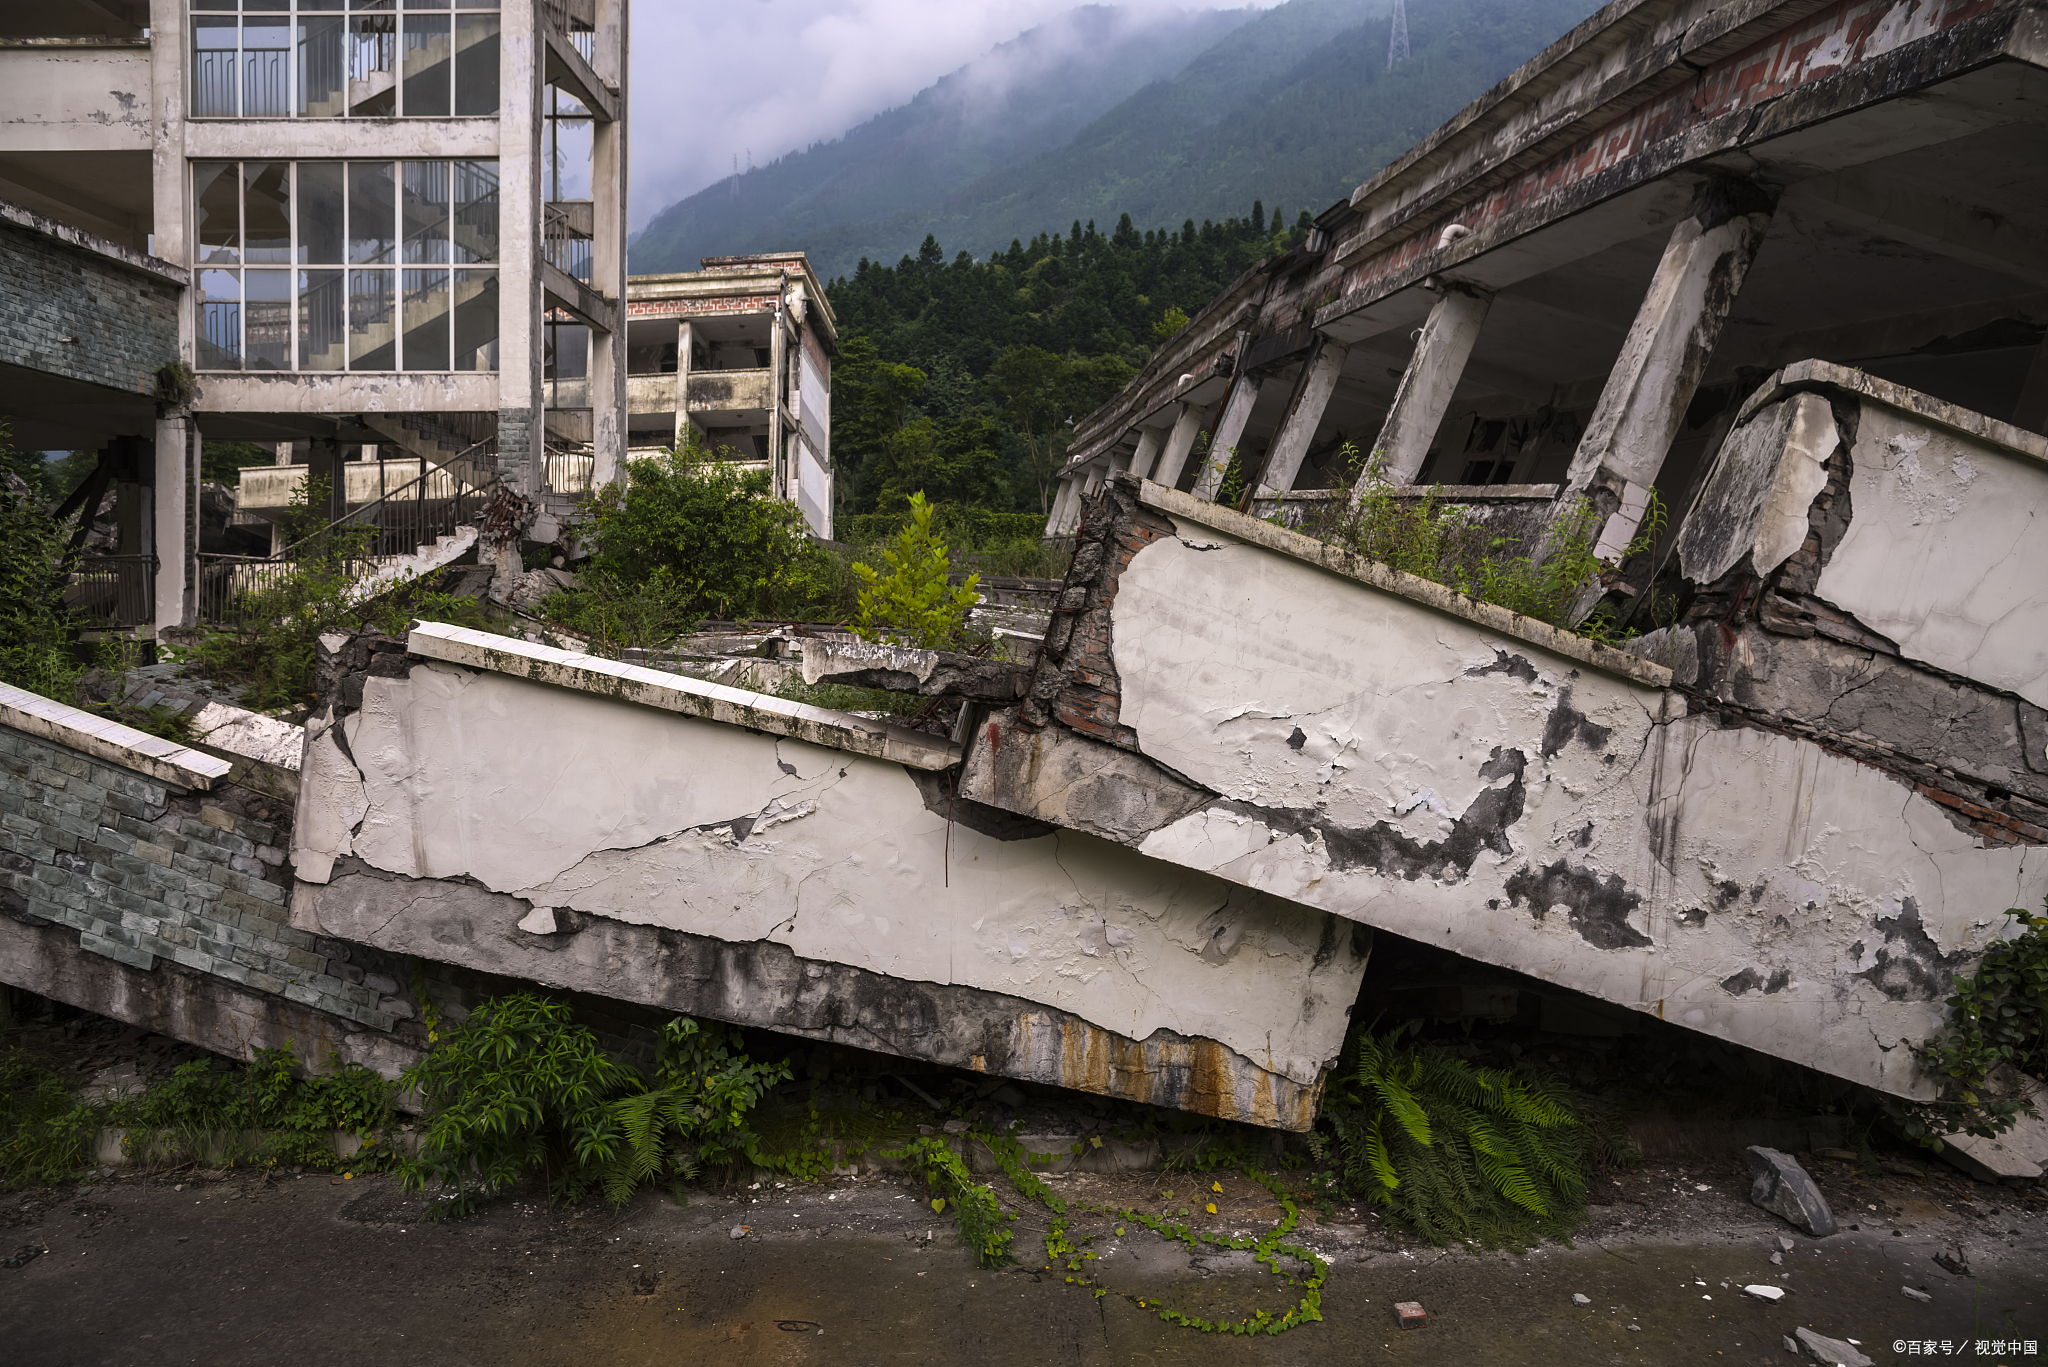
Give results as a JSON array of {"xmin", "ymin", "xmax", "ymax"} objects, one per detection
[{"xmin": 295, "ymin": 664, "xmax": 1362, "ymax": 1084}]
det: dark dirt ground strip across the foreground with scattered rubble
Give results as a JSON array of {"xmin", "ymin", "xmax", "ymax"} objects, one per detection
[{"xmin": 0, "ymin": 1156, "xmax": 2048, "ymax": 1367}]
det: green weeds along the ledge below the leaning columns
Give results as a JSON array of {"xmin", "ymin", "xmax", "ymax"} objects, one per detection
[{"xmin": 1300, "ymin": 445, "xmax": 1665, "ymax": 641}]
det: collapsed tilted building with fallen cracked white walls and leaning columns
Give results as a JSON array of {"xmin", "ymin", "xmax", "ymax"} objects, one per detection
[{"xmin": 0, "ymin": 0, "xmax": 2048, "ymax": 1176}]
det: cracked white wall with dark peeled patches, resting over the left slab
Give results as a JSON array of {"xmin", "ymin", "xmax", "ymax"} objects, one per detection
[{"xmin": 963, "ymin": 482, "xmax": 2048, "ymax": 1094}]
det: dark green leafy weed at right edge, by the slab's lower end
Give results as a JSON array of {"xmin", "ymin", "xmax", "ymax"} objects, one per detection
[{"xmin": 1884, "ymin": 900, "xmax": 2048, "ymax": 1150}]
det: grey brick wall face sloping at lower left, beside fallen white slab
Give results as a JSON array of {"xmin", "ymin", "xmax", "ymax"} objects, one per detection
[{"xmin": 0, "ymin": 728, "xmax": 397, "ymax": 1031}]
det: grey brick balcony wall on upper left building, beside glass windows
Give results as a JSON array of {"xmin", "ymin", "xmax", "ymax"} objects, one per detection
[{"xmin": 0, "ymin": 223, "xmax": 180, "ymax": 393}]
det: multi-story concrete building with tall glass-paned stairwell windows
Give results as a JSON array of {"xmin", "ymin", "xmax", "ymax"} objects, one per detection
[{"xmin": 0, "ymin": 0, "xmax": 627, "ymax": 625}]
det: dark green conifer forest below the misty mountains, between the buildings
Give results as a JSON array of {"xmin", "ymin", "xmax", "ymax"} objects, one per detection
[{"xmin": 829, "ymin": 203, "xmax": 1307, "ymax": 514}]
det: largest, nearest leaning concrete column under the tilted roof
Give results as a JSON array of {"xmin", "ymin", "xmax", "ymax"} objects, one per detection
[{"xmin": 1559, "ymin": 180, "xmax": 1776, "ymax": 561}]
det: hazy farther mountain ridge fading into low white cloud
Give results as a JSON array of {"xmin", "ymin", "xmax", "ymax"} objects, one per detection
[{"xmin": 631, "ymin": 0, "xmax": 1253, "ymax": 275}]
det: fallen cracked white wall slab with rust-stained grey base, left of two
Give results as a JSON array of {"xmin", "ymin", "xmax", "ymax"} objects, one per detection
[{"xmin": 293, "ymin": 644, "xmax": 1370, "ymax": 1129}]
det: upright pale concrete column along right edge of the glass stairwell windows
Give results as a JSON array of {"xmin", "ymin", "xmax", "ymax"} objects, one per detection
[{"xmin": 498, "ymin": 0, "xmax": 547, "ymax": 498}]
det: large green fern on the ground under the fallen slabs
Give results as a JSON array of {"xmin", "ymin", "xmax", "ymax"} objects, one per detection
[{"xmin": 1309, "ymin": 1029, "xmax": 1606, "ymax": 1248}]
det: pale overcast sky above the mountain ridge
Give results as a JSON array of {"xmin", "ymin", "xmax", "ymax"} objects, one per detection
[{"xmin": 629, "ymin": 0, "xmax": 1278, "ymax": 227}]
